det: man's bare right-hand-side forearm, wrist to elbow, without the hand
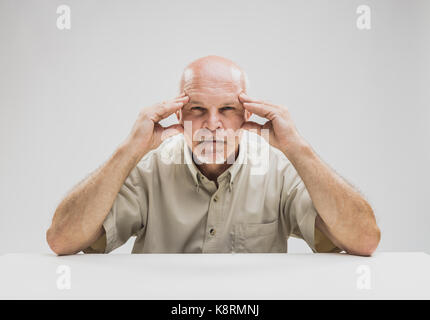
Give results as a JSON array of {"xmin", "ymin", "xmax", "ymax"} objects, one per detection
[{"xmin": 284, "ymin": 139, "xmax": 380, "ymax": 255}]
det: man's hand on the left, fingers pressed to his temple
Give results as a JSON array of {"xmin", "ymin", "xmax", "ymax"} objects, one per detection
[{"xmin": 125, "ymin": 93, "xmax": 189, "ymax": 159}]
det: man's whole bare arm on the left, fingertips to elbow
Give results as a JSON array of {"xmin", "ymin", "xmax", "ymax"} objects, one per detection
[{"xmin": 46, "ymin": 95, "xmax": 188, "ymax": 255}]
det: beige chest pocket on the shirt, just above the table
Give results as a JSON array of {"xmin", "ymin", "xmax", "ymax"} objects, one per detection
[{"xmin": 232, "ymin": 220, "xmax": 287, "ymax": 253}]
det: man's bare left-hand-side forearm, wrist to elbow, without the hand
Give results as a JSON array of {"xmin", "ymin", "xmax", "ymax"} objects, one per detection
[{"xmin": 46, "ymin": 143, "xmax": 141, "ymax": 254}]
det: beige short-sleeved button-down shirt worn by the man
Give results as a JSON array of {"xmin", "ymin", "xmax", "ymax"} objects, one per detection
[{"xmin": 83, "ymin": 133, "xmax": 341, "ymax": 253}]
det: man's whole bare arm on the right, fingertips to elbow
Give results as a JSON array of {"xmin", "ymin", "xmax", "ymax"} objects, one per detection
[{"xmin": 239, "ymin": 93, "xmax": 381, "ymax": 256}]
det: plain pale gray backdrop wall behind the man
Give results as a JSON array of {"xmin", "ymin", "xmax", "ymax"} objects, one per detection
[{"xmin": 0, "ymin": 0, "xmax": 430, "ymax": 253}]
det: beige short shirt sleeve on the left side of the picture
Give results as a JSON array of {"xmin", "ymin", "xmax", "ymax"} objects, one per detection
[{"xmin": 82, "ymin": 167, "xmax": 147, "ymax": 253}]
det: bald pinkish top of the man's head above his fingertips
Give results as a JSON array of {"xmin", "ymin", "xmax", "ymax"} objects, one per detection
[{"xmin": 180, "ymin": 56, "xmax": 248, "ymax": 93}]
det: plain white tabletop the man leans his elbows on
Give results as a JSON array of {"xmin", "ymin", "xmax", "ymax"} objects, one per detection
[{"xmin": 0, "ymin": 252, "xmax": 430, "ymax": 300}]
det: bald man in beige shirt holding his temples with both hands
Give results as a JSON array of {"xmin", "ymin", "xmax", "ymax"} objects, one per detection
[{"xmin": 47, "ymin": 56, "xmax": 380, "ymax": 256}]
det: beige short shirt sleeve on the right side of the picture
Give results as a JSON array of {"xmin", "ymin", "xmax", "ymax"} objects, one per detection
[{"xmin": 282, "ymin": 165, "xmax": 342, "ymax": 252}]
